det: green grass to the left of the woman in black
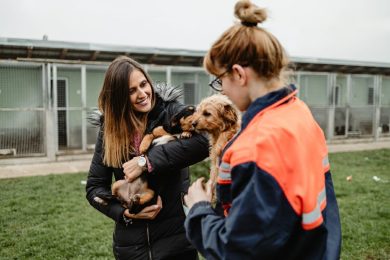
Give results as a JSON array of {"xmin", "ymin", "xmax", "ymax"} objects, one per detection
[{"xmin": 0, "ymin": 173, "xmax": 113, "ymax": 259}]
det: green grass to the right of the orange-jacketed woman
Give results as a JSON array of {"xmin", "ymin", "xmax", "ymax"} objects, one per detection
[{"xmin": 330, "ymin": 150, "xmax": 390, "ymax": 259}]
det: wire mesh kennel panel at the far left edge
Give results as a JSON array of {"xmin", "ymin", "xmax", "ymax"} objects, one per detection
[{"xmin": 0, "ymin": 63, "xmax": 45, "ymax": 158}]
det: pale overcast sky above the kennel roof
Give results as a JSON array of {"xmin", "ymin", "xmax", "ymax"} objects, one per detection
[{"xmin": 0, "ymin": 0, "xmax": 390, "ymax": 63}]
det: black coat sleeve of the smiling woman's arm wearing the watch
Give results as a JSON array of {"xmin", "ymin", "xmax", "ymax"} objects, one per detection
[{"xmin": 147, "ymin": 102, "xmax": 209, "ymax": 172}]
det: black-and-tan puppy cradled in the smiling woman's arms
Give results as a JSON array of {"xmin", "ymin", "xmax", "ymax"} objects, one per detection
[{"xmin": 111, "ymin": 106, "xmax": 195, "ymax": 213}]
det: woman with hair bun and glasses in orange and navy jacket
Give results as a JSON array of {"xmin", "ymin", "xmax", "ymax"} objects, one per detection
[{"xmin": 184, "ymin": 1, "xmax": 341, "ymax": 259}]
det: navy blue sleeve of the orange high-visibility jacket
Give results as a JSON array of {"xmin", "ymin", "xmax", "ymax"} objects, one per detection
[{"xmin": 185, "ymin": 163, "xmax": 298, "ymax": 259}]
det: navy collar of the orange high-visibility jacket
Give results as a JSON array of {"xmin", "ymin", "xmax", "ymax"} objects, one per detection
[{"xmin": 241, "ymin": 84, "xmax": 296, "ymax": 130}]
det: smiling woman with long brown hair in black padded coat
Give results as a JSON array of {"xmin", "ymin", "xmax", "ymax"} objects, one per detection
[{"xmin": 86, "ymin": 56, "xmax": 208, "ymax": 259}]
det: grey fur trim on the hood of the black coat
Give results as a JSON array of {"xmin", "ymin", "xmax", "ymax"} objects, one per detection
[{"xmin": 87, "ymin": 83, "xmax": 183, "ymax": 127}]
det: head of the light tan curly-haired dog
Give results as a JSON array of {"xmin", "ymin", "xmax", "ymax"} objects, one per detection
[{"xmin": 192, "ymin": 94, "xmax": 240, "ymax": 134}]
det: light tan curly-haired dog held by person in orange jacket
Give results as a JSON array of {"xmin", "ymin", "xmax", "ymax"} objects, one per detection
[{"xmin": 192, "ymin": 94, "xmax": 241, "ymax": 196}]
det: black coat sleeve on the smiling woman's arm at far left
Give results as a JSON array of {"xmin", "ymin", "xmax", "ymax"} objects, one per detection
[{"xmin": 86, "ymin": 131, "xmax": 125, "ymax": 222}]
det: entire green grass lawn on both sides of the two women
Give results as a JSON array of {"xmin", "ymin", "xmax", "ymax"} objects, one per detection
[{"xmin": 0, "ymin": 150, "xmax": 390, "ymax": 260}]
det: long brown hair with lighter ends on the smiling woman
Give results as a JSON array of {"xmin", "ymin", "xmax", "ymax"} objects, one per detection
[{"xmin": 98, "ymin": 56, "xmax": 156, "ymax": 167}]
